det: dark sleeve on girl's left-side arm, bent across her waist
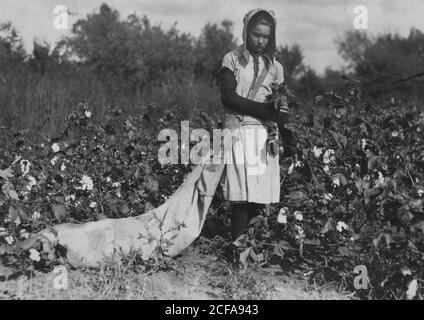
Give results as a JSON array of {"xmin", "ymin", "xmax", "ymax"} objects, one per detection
[{"xmin": 220, "ymin": 67, "xmax": 278, "ymax": 121}]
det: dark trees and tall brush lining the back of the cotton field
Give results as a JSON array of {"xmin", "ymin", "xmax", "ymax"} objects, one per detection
[{"xmin": 0, "ymin": 4, "xmax": 424, "ymax": 134}]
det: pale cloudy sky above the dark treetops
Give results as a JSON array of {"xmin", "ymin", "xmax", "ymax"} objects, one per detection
[{"xmin": 0, "ymin": 0, "xmax": 424, "ymax": 73}]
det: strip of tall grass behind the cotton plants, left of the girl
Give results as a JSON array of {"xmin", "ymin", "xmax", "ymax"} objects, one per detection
[{"xmin": 0, "ymin": 68, "xmax": 222, "ymax": 136}]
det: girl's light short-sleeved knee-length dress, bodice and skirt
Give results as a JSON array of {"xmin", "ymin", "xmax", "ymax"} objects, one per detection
[{"xmin": 221, "ymin": 48, "xmax": 284, "ymax": 204}]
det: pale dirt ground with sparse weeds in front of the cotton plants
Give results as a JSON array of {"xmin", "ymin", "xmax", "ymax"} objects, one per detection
[{"xmin": 0, "ymin": 247, "xmax": 352, "ymax": 300}]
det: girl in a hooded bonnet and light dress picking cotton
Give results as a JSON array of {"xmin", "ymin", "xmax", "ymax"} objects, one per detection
[{"xmin": 220, "ymin": 9, "xmax": 295, "ymax": 240}]
